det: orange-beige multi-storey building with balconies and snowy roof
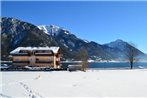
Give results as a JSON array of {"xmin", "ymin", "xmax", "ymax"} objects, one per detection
[{"xmin": 10, "ymin": 47, "xmax": 60, "ymax": 69}]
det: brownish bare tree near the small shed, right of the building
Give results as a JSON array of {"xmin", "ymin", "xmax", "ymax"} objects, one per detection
[{"xmin": 79, "ymin": 48, "xmax": 88, "ymax": 72}]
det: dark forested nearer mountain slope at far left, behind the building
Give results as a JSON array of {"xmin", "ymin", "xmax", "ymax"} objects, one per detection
[{"xmin": 0, "ymin": 17, "xmax": 56, "ymax": 60}]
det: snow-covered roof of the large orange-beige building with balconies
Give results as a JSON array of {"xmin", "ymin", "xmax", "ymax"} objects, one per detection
[{"xmin": 10, "ymin": 47, "xmax": 60, "ymax": 54}]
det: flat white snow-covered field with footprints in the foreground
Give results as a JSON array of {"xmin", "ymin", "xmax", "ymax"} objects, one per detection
[{"xmin": 0, "ymin": 69, "xmax": 147, "ymax": 98}]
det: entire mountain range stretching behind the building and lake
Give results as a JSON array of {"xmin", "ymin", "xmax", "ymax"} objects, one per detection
[{"xmin": 1, "ymin": 17, "xmax": 145, "ymax": 60}]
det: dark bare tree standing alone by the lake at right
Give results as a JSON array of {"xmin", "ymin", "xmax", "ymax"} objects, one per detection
[{"xmin": 125, "ymin": 43, "xmax": 138, "ymax": 69}]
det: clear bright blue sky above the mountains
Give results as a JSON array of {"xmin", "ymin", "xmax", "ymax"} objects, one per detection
[{"xmin": 1, "ymin": 1, "xmax": 147, "ymax": 53}]
